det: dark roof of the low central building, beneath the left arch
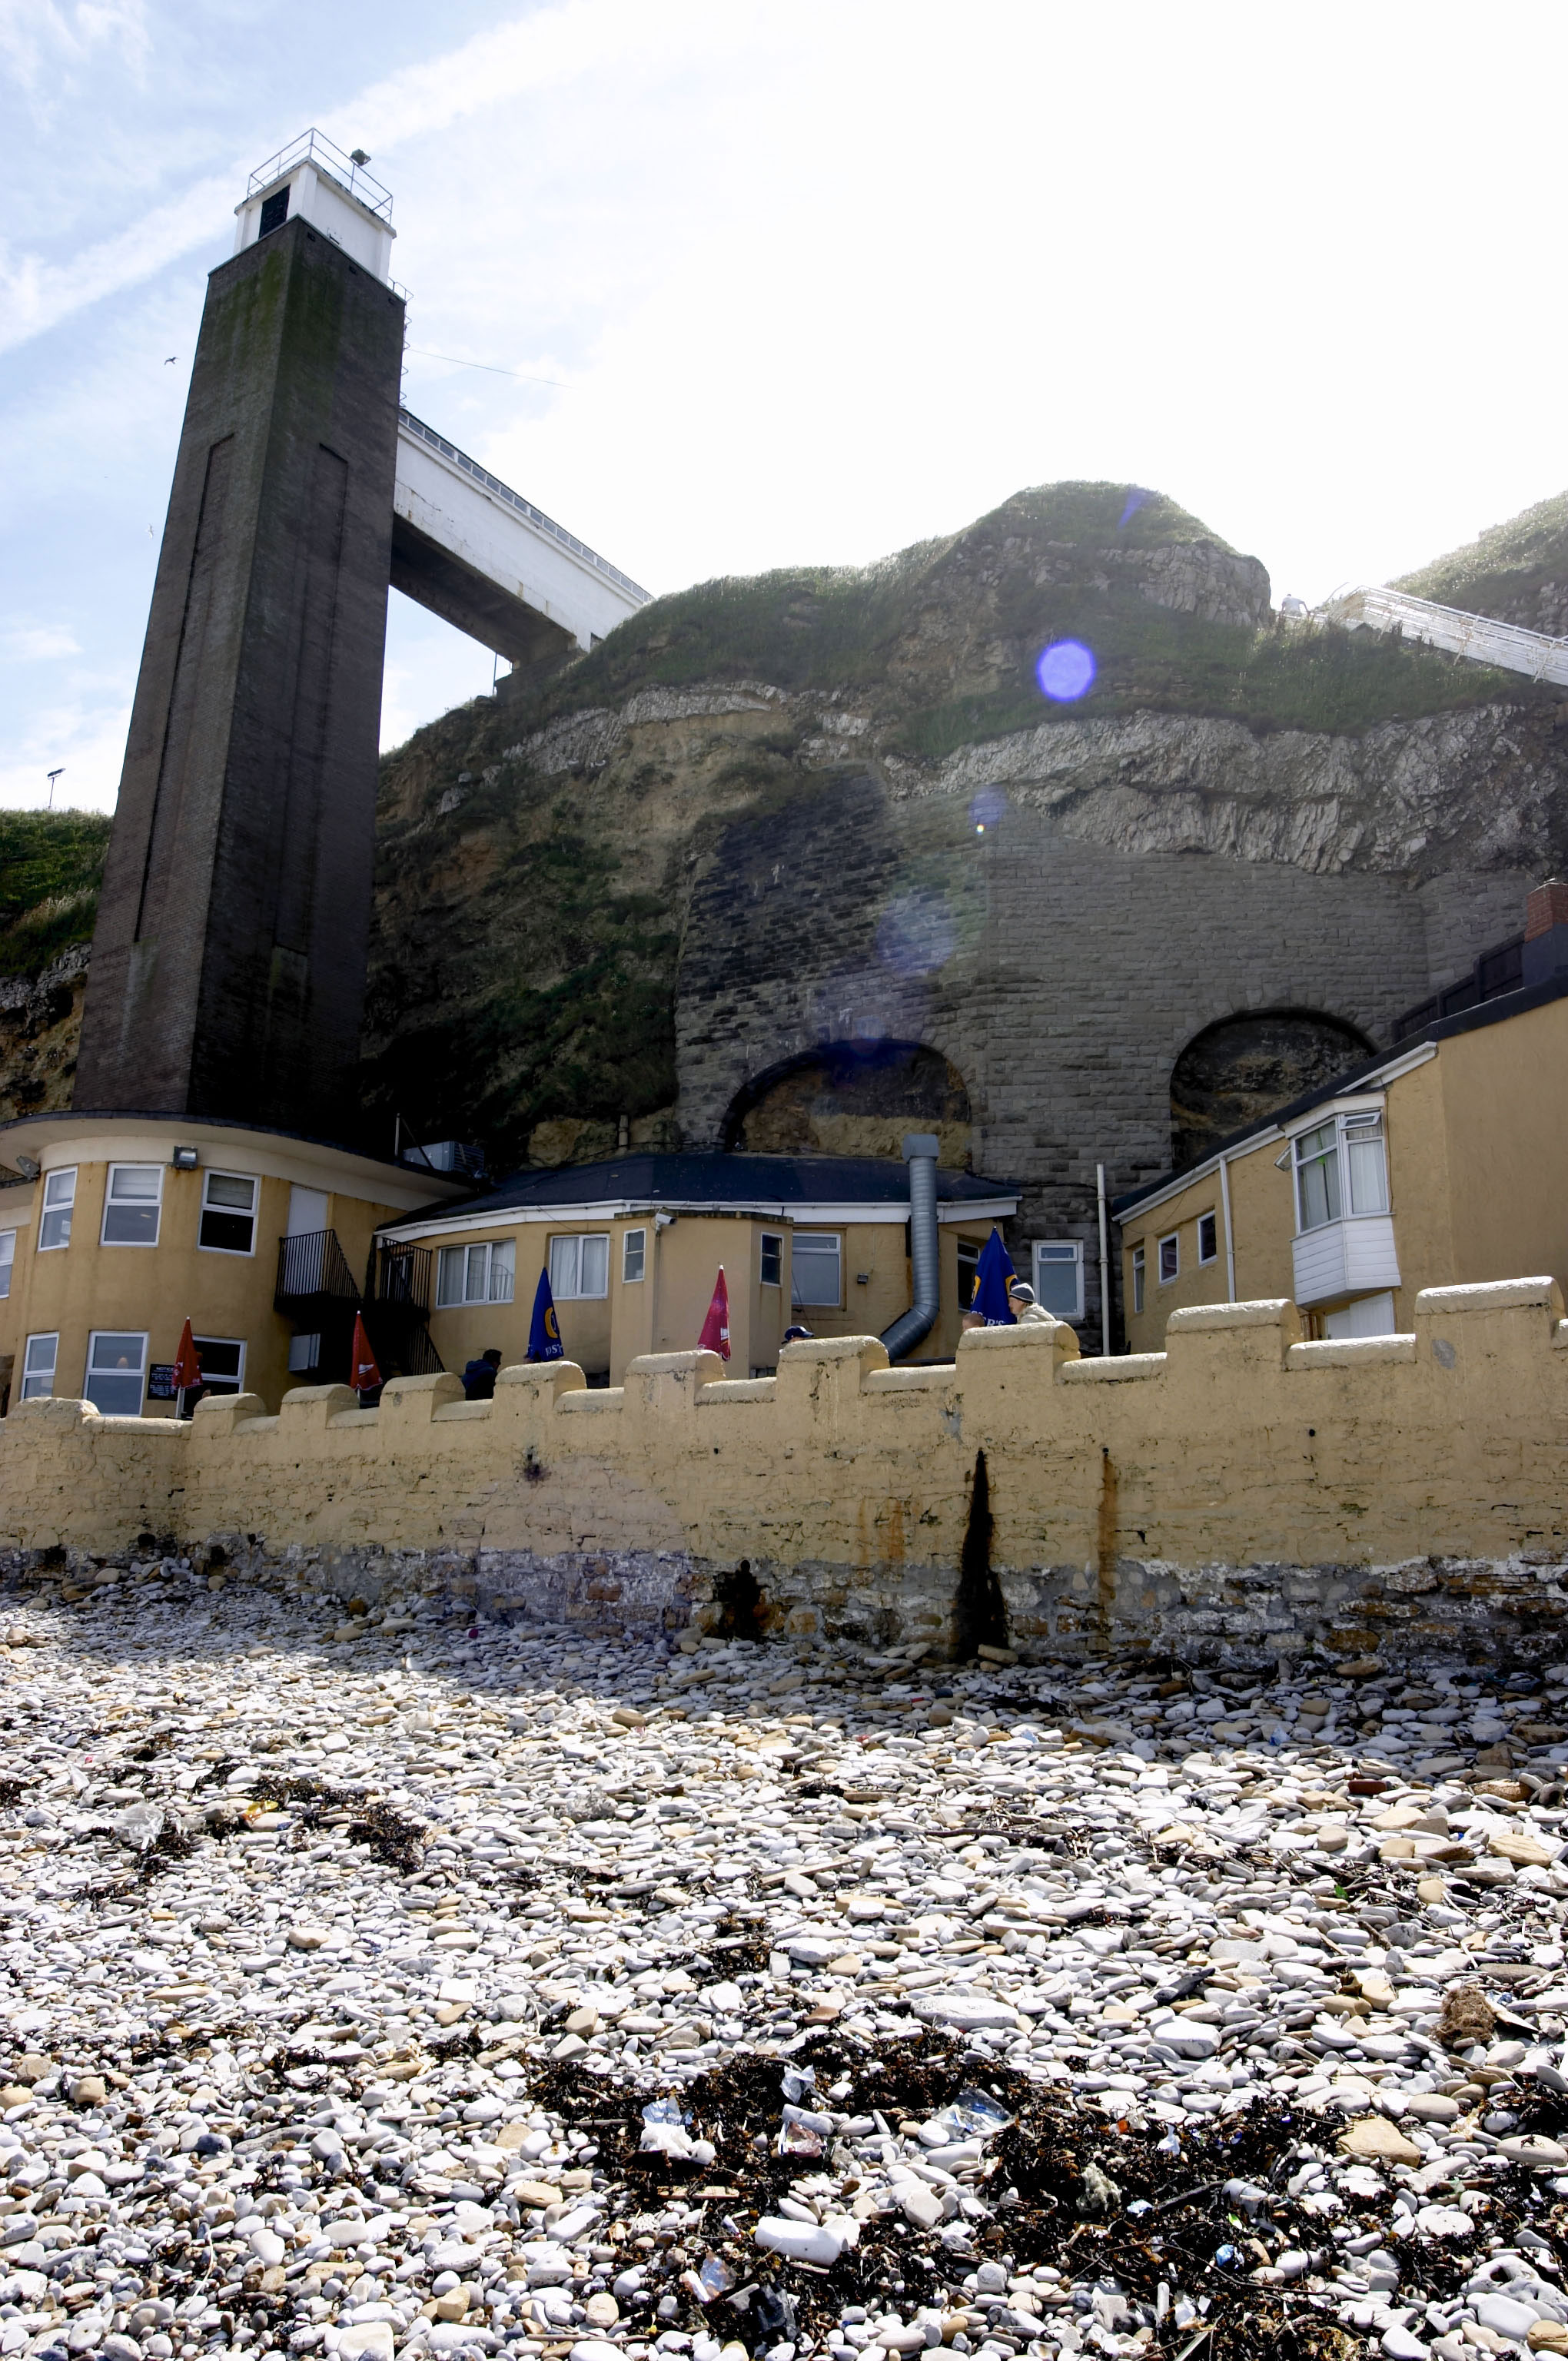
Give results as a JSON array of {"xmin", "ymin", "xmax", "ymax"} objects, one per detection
[{"xmin": 390, "ymin": 1152, "xmax": 1022, "ymax": 1230}]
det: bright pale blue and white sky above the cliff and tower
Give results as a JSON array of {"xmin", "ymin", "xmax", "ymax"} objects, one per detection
[{"xmin": 0, "ymin": 0, "xmax": 1568, "ymax": 810}]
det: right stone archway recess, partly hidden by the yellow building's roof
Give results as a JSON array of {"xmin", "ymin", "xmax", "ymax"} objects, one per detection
[{"xmin": 1171, "ymin": 1008, "xmax": 1372, "ymax": 1169}]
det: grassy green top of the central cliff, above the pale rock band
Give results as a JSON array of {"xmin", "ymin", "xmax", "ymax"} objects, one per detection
[{"xmin": 432, "ymin": 484, "xmax": 1530, "ymax": 760}]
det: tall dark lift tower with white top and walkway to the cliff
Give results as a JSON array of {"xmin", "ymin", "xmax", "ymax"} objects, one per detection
[{"xmin": 75, "ymin": 132, "xmax": 647, "ymax": 1141}]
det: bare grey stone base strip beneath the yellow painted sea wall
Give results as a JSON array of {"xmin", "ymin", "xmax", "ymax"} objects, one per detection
[{"xmin": 0, "ymin": 1535, "xmax": 1568, "ymax": 1669}]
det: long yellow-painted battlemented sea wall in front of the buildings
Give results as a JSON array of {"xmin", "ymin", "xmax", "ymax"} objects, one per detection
[{"xmin": 0, "ymin": 1280, "xmax": 1568, "ymax": 1645}]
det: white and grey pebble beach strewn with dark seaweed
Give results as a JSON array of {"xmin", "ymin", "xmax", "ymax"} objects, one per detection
[{"xmin": 0, "ymin": 1559, "xmax": 1568, "ymax": 2361}]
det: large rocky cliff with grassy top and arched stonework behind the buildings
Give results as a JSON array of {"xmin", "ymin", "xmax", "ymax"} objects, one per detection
[{"xmin": 0, "ymin": 484, "xmax": 1568, "ymax": 1303}]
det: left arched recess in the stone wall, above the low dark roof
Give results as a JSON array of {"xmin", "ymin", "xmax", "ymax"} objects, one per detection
[{"xmin": 723, "ymin": 1039, "xmax": 973, "ymax": 1171}]
